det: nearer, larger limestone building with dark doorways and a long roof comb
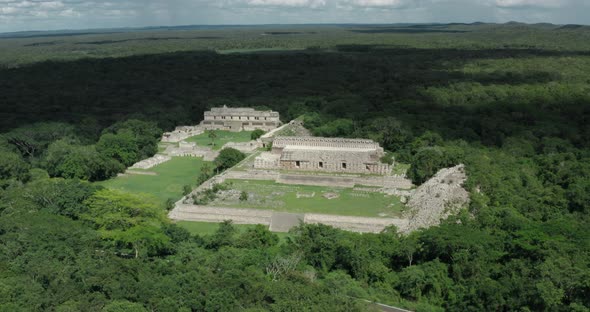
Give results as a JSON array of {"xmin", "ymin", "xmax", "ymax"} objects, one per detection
[{"xmin": 254, "ymin": 137, "xmax": 391, "ymax": 175}]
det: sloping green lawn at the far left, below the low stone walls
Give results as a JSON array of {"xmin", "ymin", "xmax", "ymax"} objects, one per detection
[{"xmin": 99, "ymin": 157, "xmax": 204, "ymax": 204}]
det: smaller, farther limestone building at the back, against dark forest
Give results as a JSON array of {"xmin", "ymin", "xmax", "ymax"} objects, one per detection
[{"xmin": 201, "ymin": 106, "xmax": 281, "ymax": 132}]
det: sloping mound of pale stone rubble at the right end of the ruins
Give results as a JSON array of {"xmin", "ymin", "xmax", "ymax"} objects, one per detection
[{"xmin": 403, "ymin": 165, "xmax": 469, "ymax": 232}]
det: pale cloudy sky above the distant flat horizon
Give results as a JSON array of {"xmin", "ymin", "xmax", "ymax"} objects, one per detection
[{"xmin": 0, "ymin": 0, "xmax": 590, "ymax": 32}]
